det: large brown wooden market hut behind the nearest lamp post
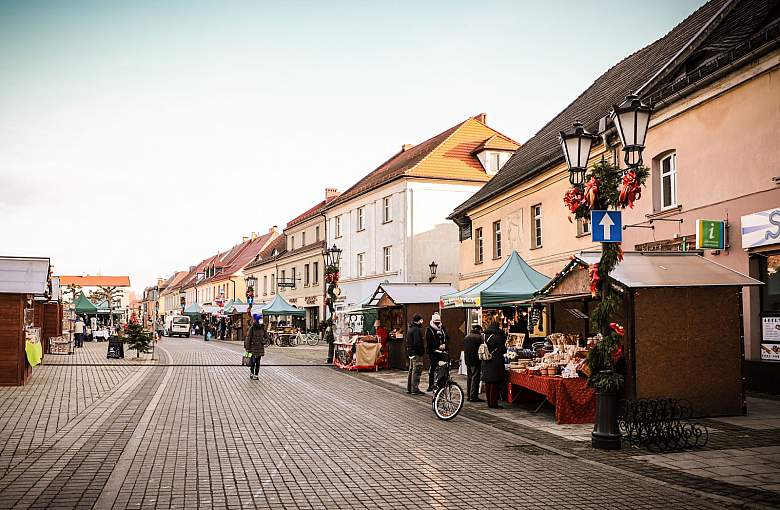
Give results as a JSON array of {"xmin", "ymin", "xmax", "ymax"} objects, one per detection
[{"xmin": 533, "ymin": 252, "xmax": 761, "ymax": 416}]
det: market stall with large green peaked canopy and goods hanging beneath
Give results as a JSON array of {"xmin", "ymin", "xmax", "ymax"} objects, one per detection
[{"xmin": 441, "ymin": 251, "xmax": 550, "ymax": 347}]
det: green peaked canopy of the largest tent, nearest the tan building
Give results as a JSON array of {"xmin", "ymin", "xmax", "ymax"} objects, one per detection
[{"xmin": 441, "ymin": 251, "xmax": 550, "ymax": 308}]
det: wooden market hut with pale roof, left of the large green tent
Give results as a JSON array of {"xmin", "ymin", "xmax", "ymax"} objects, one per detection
[{"xmin": 366, "ymin": 283, "xmax": 458, "ymax": 370}]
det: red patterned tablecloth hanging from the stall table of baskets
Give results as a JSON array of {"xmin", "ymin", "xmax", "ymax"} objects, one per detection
[{"xmin": 509, "ymin": 370, "xmax": 596, "ymax": 423}]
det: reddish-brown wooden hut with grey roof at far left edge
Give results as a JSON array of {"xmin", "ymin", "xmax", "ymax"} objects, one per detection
[{"xmin": 0, "ymin": 257, "xmax": 50, "ymax": 386}]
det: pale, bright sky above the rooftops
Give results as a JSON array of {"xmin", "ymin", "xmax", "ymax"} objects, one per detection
[{"xmin": 0, "ymin": 0, "xmax": 703, "ymax": 290}]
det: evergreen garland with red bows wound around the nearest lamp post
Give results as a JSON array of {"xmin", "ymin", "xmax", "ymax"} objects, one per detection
[{"xmin": 563, "ymin": 160, "xmax": 649, "ymax": 392}]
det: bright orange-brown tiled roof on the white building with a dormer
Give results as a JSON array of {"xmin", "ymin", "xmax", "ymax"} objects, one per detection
[{"xmin": 325, "ymin": 115, "xmax": 510, "ymax": 209}]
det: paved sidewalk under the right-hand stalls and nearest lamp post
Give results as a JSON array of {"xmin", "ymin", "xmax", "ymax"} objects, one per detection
[{"xmin": 356, "ymin": 370, "xmax": 780, "ymax": 507}]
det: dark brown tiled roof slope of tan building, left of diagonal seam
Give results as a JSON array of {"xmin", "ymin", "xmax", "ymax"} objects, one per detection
[{"xmin": 450, "ymin": 0, "xmax": 736, "ymax": 218}]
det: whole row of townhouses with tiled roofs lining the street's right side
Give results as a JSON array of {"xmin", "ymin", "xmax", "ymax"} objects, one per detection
[{"xmin": 142, "ymin": 0, "xmax": 780, "ymax": 390}]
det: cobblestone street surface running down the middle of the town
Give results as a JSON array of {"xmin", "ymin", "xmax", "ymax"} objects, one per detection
[{"xmin": 0, "ymin": 339, "xmax": 773, "ymax": 509}]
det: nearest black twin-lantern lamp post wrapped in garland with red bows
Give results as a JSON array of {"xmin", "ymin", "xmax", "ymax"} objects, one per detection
[{"xmin": 560, "ymin": 94, "xmax": 652, "ymax": 450}]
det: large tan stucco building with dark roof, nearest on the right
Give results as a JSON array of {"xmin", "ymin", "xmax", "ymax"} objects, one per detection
[{"xmin": 451, "ymin": 0, "xmax": 780, "ymax": 390}]
